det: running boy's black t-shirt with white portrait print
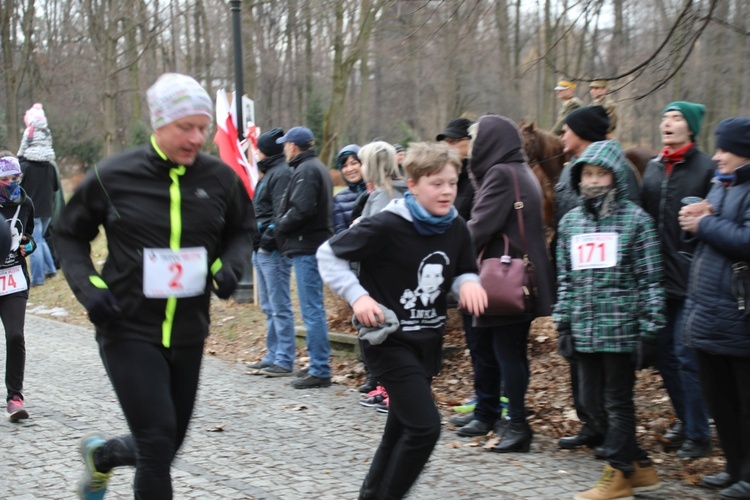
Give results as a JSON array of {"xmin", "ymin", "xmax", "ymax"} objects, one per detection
[{"xmin": 329, "ymin": 211, "xmax": 477, "ymax": 377}]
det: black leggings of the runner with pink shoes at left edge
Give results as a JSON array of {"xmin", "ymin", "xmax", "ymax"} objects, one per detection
[{"xmin": 0, "ymin": 293, "xmax": 27, "ymax": 401}]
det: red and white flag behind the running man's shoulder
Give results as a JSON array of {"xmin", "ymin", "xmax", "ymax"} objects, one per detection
[{"xmin": 214, "ymin": 89, "xmax": 258, "ymax": 199}]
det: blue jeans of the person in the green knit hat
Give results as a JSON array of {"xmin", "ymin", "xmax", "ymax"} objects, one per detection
[{"xmin": 659, "ymin": 299, "xmax": 710, "ymax": 441}]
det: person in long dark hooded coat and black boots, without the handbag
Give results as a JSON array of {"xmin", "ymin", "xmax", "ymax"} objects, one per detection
[{"xmin": 458, "ymin": 115, "xmax": 554, "ymax": 453}]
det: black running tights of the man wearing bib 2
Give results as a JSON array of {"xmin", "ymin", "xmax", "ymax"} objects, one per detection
[{"xmin": 94, "ymin": 336, "xmax": 203, "ymax": 500}]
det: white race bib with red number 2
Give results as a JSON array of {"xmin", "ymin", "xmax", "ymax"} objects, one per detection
[{"xmin": 143, "ymin": 247, "xmax": 208, "ymax": 299}]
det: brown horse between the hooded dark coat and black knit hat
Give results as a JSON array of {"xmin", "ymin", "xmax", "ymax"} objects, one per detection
[{"xmin": 518, "ymin": 120, "xmax": 569, "ymax": 228}]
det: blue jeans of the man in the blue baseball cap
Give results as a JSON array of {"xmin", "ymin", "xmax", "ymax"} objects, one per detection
[{"xmin": 292, "ymin": 254, "xmax": 331, "ymax": 378}]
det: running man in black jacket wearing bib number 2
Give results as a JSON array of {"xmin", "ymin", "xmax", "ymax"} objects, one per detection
[{"xmin": 55, "ymin": 73, "xmax": 255, "ymax": 500}]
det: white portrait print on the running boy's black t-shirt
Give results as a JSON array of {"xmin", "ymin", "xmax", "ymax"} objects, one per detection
[{"xmin": 400, "ymin": 252, "xmax": 450, "ymax": 330}]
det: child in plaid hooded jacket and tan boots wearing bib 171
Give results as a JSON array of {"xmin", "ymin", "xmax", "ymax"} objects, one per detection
[{"xmin": 554, "ymin": 140, "xmax": 665, "ymax": 499}]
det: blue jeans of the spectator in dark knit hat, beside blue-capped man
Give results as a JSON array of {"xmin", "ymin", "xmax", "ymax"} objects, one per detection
[{"xmin": 253, "ymin": 251, "xmax": 295, "ymax": 370}]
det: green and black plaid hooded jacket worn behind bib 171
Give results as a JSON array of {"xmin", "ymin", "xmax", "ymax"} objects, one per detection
[{"xmin": 554, "ymin": 141, "xmax": 665, "ymax": 353}]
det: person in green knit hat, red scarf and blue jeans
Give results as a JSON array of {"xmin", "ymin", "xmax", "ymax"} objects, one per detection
[{"xmin": 641, "ymin": 101, "xmax": 714, "ymax": 458}]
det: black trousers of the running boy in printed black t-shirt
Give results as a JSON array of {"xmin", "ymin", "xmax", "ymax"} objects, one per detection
[{"xmin": 360, "ymin": 367, "xmax": 440, "ymax": 500}]
